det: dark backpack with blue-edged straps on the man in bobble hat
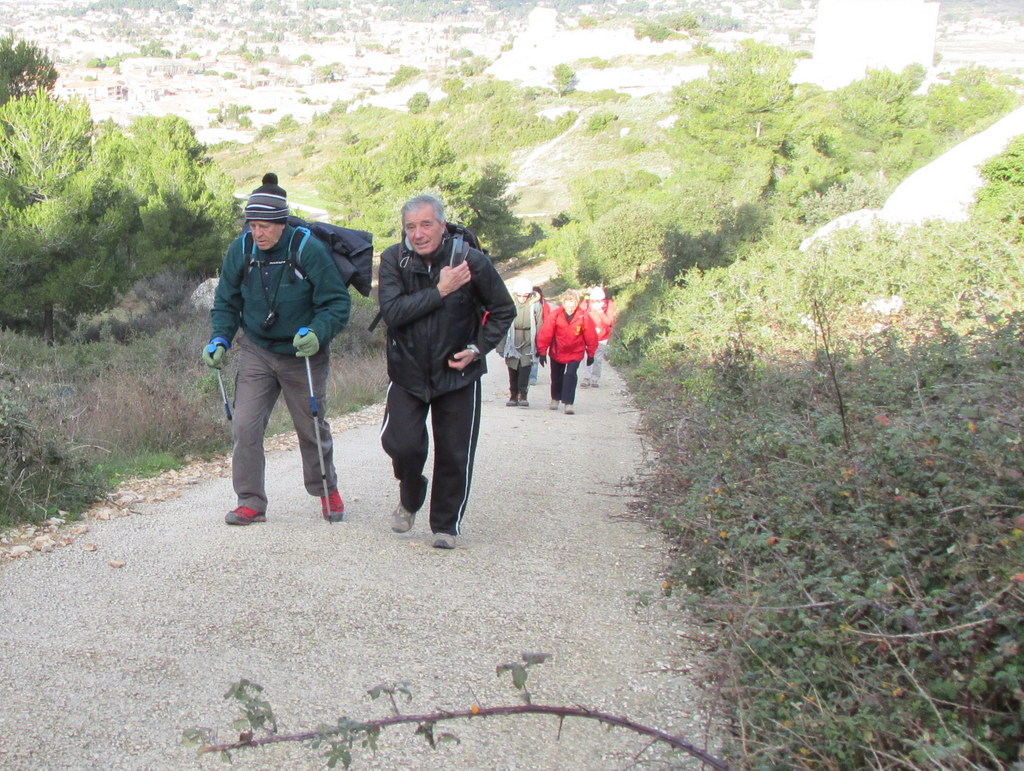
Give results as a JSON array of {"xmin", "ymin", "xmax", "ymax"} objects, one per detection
[{"xmin": 242, "ymin": 217, "xmax": 374, "ymax": 297}]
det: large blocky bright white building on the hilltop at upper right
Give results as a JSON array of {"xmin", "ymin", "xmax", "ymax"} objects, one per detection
[{"xmin": 794, "ymin": 0, "xmax": 939, "ymax": 90}]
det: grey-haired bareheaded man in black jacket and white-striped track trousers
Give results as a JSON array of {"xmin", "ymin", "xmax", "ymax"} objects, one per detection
[{"xmin": 378, "ymin": 196, "xmax": 515, "ymax": 549}]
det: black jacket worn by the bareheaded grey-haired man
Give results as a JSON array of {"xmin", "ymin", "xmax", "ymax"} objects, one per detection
[{"xmin": 378, "ymin": 239, "xmax": 515, "ymax": 401}]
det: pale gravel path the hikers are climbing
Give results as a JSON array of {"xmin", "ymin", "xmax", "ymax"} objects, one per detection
[{"xmin": 0, "ymin": 356, "xmax": 703, "ymax": 771}]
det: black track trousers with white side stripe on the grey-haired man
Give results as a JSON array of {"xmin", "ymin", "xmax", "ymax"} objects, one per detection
[{"xmin": 381, "ymin": 380, "xmax": 480, "ymax": 536}]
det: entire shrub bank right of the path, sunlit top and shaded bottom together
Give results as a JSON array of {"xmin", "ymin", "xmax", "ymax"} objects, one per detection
[{"xmin": 612, "ymin": 154, "xmax": 1024, "ymax": 769}]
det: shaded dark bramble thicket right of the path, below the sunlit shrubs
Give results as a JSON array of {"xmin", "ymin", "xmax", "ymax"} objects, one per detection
[{"xmin": 634, "ymin": 317, "xmax": 1024, "ymax": 769}]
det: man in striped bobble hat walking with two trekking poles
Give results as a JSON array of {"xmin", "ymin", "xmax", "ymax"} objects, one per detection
[{"xmin": 203, "ymin": 174, "xmax": 351, "ymax": 525}]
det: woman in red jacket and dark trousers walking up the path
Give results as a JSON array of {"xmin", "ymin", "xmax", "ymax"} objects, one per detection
[{"xmin": 537, "ymin": 289, "xmax": 597, "ymax": 415}]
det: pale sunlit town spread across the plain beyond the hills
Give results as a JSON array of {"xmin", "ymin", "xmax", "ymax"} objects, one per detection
[{"xmin": 0, "ymin": 0, "xmax": 1024, "ymax": 143}]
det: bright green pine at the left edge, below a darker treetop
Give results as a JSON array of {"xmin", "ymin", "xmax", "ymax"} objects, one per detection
[{"xmin": 0, "ymin": 92, "xmax": 131, "ymax": 338}]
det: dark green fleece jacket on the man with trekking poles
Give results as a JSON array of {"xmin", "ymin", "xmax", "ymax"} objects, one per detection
[{"xmin": 210, "ymin": 225, "xmax": 352, "ymax": 355}]
